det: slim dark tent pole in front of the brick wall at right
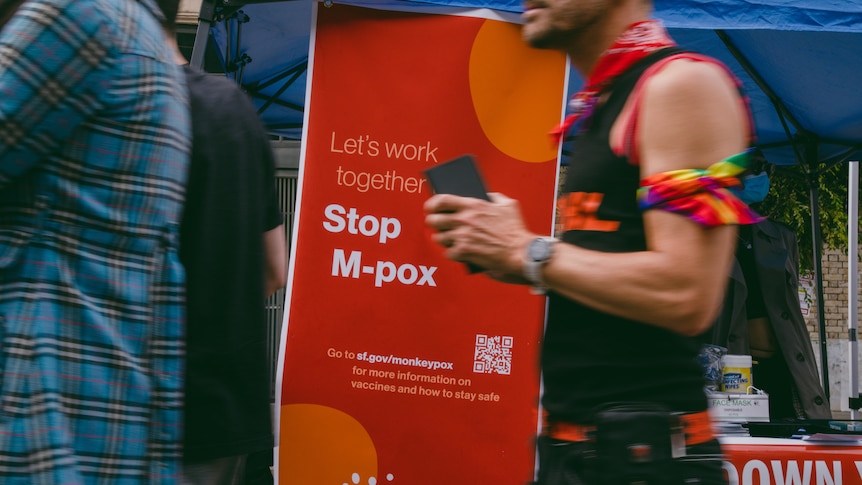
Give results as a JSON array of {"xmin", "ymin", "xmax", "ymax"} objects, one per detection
[{"xmin": 805, "ymin": 147, "xmax": 830, "ymax": 399}]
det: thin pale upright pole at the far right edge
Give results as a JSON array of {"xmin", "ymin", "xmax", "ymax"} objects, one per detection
[{"xmin": 847, "ymin": 161, "xmax": 860, "ymax": 419}]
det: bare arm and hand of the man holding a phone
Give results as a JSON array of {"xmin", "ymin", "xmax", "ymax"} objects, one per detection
[{"xmin": 426, "ymin": 61, "xmax": 748, "ymax": 335}]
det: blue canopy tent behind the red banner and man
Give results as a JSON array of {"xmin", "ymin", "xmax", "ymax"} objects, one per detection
[{"xmin": 192, "ymin": 0, "xmax": 862, "ymax": 410}]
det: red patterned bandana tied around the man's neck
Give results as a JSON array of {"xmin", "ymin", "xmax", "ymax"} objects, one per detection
[{"xmin": 551, "ymin": 20, "xmax": 676, "ymax": 145}]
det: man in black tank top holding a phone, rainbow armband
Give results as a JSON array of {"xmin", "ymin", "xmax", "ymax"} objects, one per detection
[{"xmin": 425, "ymin": 0, "xmax": 757, "ymax": 485}]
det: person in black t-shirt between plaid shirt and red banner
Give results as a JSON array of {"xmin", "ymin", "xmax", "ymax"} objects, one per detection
[{"xmin": 159, "ymin": 0, "xmax": 286, "ymax": 485}]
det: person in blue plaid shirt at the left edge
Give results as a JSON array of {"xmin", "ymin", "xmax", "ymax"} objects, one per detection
[{"xmin": 0, "ymin": 0, "xmax": 191, "ymax": 485}]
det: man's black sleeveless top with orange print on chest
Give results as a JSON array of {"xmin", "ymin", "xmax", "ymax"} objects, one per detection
[{"xmin": 542, "ymin": 48, "xmax": 706, "ymax": 423}]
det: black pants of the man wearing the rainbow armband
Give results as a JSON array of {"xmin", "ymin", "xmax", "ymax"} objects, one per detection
[{"xmin": 536, "ymin": 436, "xmax": 727, "ymax": 485}]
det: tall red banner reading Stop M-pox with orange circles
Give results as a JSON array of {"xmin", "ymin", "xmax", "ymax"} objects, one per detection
[{"xmin": 277, "ymin": 4, "xmax": 567, "ymax": 485}]
